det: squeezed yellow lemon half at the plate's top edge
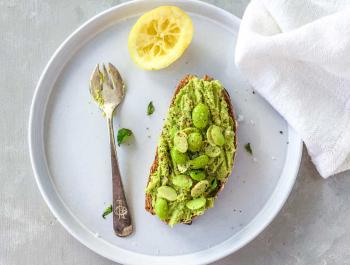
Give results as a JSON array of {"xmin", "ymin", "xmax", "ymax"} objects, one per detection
[{"xmin": 128, "ymin": 6, "xmax": 193, "ymax": 70}]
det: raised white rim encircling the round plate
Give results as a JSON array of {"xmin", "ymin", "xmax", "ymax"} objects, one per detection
[{"xmin": 28, "ymin": 0, "xmax": 303, "ymax": 264}]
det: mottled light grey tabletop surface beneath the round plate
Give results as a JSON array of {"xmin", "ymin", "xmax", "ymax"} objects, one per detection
[{"xmin": 0, "ymin": 0, "xmax": 350, "ymax": 265}]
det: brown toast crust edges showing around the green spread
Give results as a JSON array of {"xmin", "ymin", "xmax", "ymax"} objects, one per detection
[{"xmin": 145, "ymin": 75, "xmax": 237, "ymax": 224}]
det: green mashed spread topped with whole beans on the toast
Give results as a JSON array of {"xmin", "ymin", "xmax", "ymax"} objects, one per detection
[{"xmin": 146, "ymin": 78, "xmax": 235, "ymax": 226}]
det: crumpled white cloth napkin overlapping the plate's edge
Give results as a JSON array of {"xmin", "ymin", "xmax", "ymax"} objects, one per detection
[{"xmin": 235, "ymin": 0, "xmax": 350, "ymax": 178}]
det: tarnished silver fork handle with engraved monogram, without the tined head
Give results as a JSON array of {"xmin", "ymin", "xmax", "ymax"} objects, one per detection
[{"xmin": 107, "ymin": 117, "xmax": 133, "ymax": 237}]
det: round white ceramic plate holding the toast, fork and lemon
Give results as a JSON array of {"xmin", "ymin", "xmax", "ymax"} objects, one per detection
[{"xmin": 29, "ymin": 0, "xmax": 302, "ymax": 264}]
